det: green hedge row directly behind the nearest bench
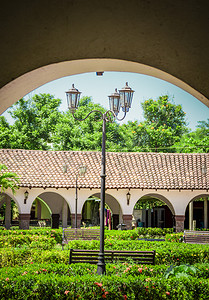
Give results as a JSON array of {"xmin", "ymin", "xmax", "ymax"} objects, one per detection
[{"xmin": 0, "ymin": 240, "xmax": 209, "ymax": 267}]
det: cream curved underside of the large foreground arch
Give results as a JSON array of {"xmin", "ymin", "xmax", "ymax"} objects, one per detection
[{"xmin": 0, "ymin": 58, "xmax": 209, "ymax": 114}]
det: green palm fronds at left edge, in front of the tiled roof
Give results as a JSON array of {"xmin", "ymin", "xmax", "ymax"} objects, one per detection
[{"xmin": 0, "ymin": 164, "xmax": 19, "ymax": 194}]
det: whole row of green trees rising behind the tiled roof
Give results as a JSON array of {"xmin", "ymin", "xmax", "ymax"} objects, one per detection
[{"xmin": 0, "ymin": 94, "xmax": 209, "ymax": 152}]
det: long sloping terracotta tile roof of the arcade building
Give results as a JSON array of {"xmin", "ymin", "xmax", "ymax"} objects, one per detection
[{"xmin": 0, "ymin": 149, "xmax": 209, "ymax": 190}]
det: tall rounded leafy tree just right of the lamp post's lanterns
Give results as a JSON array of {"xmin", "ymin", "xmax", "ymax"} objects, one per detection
[{"xmin": 120, "ymin": 95, "xmax": 187, "ymax": 152}]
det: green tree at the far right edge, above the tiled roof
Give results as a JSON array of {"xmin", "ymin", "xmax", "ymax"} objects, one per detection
[{"xmin": 174, "ymin": 119, "xmax": 209, "ymax": 153}]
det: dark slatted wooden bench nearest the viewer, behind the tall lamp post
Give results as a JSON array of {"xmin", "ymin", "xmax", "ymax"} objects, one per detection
[{"xmin": 69, "ymin": 249, "xmax": 155, "ymax": 265}]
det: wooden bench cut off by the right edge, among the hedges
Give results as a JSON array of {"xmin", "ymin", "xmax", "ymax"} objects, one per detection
[{"xmin": 183, "ymin": 230, "xmax": 209, "ymax": 244}]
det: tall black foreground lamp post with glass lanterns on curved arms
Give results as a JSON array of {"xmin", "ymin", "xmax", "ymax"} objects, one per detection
[{"xmin": 66, "ymin": 82, "xmax": 134, "ymax": 275}]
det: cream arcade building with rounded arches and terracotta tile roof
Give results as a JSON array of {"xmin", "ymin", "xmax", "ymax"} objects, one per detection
[{"xmin": 0, "ymin": 149, "xmax": 209, "ymax": 231}]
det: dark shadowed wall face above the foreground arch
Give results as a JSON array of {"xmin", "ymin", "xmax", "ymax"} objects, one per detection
[{"xmin": 0, "ymin": 0, "xmax": 209, "ymax": 116}]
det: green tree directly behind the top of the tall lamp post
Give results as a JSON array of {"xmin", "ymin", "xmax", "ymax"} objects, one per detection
[{"xmin": 52, "ymin": 97, "xmax": 120, "ymax": 151}]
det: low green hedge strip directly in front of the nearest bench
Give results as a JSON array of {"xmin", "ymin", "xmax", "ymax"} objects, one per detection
[{"xmin": 0, "ymin": 262, "xmax": 209, "ymax": 279}]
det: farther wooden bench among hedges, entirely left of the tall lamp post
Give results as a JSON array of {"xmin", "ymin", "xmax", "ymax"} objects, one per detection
[{"xmin": 62, "ymin": 228, "xmax": 100, "ymax": 250}]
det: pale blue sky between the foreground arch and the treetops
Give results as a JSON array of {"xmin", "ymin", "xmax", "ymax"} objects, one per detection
[{"xmin": 3, "ymin": 72, "xmax": 209, "ymax": 130}]
